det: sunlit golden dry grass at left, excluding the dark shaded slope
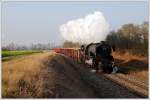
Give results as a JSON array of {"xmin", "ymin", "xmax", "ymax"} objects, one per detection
[{"xmin": 2, "ymin": 53, "xmax": 54, "ymax": 98}]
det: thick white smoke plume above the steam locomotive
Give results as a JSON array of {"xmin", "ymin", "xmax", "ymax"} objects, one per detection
[{"xmin": 60, "ymin": 11, "xmax": 109, "ymax": 44}]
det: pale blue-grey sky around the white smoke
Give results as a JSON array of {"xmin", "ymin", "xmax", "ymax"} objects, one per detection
[{"xmin": 1, "ymin": 1, "xmax": 149, "ymax": 46}]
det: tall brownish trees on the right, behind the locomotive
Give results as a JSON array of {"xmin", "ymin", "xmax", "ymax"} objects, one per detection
[{"xmin": 106, "ymin": 22, "xmax": 148, "ymax": 55}]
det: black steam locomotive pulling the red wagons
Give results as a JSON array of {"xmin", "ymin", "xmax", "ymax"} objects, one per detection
[{"xmin": 81, "ymin": 41, "xmax": 117, "ymax": 73}]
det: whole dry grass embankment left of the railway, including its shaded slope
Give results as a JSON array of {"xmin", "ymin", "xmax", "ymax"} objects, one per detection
[{"xmin": 2, "ymin": 52, "xmax": 96, "ymax": 98}]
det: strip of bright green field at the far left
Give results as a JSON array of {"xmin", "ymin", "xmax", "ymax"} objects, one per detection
[{"xmin": 2, "ymin": 50, "xmax": 42, "ymax": 58}]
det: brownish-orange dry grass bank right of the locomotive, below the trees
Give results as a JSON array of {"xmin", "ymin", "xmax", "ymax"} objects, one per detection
[{"xmin": 113, "ymin": 52, "xmax": 148, "ymax": 83}]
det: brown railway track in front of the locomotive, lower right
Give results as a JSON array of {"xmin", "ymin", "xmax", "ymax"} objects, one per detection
[{"xmin": 103, "ymin": 74, "xmax": 148, "ymax": 97}]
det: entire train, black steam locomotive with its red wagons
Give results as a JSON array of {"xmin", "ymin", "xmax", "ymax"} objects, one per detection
[{"xmin": 53, "ymin": 42, "xmax": 117, "ymax": 73}]
